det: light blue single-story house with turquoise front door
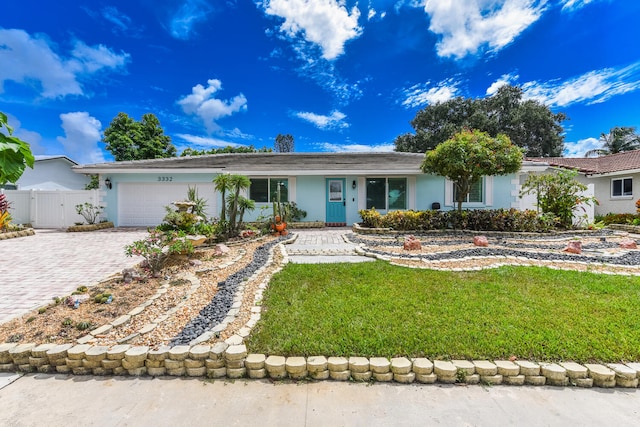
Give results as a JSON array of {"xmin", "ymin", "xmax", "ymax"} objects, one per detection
[{"xmin": 73, "ymin": 152, "xmax": 548, "ymax": 226}]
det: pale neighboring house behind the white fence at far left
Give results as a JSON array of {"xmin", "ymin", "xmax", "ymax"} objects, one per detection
[{"xmin": 11, "ymin": 156, "xmax": 90, "ymax": 190}]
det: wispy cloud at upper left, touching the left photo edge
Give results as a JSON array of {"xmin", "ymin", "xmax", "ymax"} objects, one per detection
[{"xmin": 0, "ymin": 29, "xmax": 129, "ymax": 98}]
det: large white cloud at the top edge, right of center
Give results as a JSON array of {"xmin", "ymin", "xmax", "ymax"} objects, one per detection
[{"xmin": 424, "ymin": 0, "xmax": 547, "ymax": 59}]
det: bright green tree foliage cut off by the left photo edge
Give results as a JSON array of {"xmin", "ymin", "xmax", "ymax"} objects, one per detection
[{"xmin": 0, "ymin": 111, "xmax": 35, "ymax": 185}]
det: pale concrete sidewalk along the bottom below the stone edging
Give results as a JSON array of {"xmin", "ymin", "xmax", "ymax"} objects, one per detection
[{"xmin": 0, "ymin": 374, "xmax": 640, "ymax": 427}]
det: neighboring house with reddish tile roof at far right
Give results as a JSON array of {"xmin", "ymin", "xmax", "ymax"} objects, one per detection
[{"xmin": 528, "ymin": 150, "xmax": 640, "ymax": 215}]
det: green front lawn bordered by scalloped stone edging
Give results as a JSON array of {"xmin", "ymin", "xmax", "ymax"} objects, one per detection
[{"xmin": 247, "ymin": 261, "xmax": 640, "ymax": 362}]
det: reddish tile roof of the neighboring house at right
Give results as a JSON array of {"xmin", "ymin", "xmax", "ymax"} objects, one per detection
[{"xmin": 527, "ymin": 150, "xmax": 640, "ymax": 174}]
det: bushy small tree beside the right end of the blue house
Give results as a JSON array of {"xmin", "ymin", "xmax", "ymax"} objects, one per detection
[{"xmin": 520, "ymin": 169, "xmax": 597, "ymax": 228}]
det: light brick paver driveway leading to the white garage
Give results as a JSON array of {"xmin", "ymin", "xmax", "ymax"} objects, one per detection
[{"xmin": 0, "ymin": 228, "xmax": 147, "ymax": 323}]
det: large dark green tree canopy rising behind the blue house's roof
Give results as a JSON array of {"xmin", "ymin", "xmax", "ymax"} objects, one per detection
[{"xmin": 394, "ymin": 85, "xmax": 566, "ymax": 157}]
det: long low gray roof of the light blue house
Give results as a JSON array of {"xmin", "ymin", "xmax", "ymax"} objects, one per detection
[{"xmin": 73, "ymin": 152, "xmax": 424, "ymax": 173}]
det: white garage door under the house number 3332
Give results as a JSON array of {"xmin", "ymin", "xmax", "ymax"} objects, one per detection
[{"xmin": 118, "ymin": 183, "xmax": 216, "ymax": 227}]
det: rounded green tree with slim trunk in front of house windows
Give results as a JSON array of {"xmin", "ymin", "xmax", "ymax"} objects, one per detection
[{"xmin": 422, "ymin": 130, "xmax": 523, "ymax": 211}]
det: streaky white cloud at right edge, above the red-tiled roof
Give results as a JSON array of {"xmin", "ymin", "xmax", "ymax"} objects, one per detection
[{"xmin": 522, "ymin": 62, "xmax": 640, "ymax": 107}]
